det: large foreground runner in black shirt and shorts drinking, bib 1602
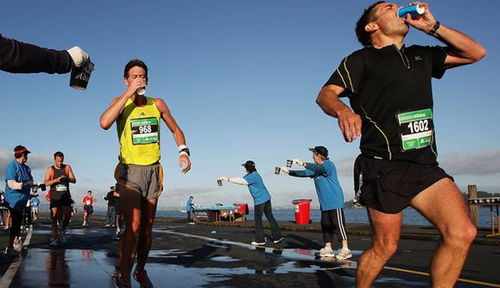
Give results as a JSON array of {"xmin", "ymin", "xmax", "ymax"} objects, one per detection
[{"xmin": 316, "ymin": 1, "xmax": 486, "ymax": 287}]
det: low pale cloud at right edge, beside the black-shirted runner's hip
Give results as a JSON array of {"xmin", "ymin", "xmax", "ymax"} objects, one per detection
[{"xmin": 439, "ymin": 149, "xmax": 500, "ymax": 176}]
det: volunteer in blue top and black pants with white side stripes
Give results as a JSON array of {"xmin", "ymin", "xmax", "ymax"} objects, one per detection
[{"xmin": 281, "ymin": 146, "xmax": 352, "ymax": 260}]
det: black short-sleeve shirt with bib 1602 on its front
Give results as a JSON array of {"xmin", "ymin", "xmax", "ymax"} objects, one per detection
[{"xmin": 325, "ymin": 45, "xmax": 446, "ymax": 164}]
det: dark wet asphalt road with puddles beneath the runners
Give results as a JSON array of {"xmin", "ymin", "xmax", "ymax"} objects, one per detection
[{"xmin": 0, "ymin": 218, "xmax": 500, "ymax": 288}]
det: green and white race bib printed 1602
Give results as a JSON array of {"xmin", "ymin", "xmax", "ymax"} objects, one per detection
[{"xmin": 396, "ymin": 109, "xmax": 434, "ymax": 151}]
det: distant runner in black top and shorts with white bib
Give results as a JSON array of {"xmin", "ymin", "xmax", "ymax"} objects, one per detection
[{"xmin": 45, "ymin": 151, "xmax": 76, "ymax": 246}]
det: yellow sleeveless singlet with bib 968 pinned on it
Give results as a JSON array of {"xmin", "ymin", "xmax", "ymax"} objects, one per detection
[{"xmin": 116, "ymin": 97, "xmax": 160, "ymax": 165}]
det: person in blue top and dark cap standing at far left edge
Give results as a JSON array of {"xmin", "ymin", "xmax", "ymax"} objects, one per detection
[{"xmin": 5, "ymin": 145, "xmax": 33, "ymax": 254}]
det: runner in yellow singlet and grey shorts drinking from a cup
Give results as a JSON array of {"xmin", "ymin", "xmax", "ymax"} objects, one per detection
[{"xmin": 100, "ymin": 59, "xmax": 191, "ymax": 287}]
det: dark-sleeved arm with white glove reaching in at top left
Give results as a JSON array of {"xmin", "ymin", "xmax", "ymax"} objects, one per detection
[{"xmin": 0, "ymin": 35, "xmax": 89, "ymax": 74}]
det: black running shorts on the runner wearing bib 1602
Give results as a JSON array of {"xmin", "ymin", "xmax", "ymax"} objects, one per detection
[{"xmin": 354, "ymin": 155, "xmax": 453, "ymax": 214}]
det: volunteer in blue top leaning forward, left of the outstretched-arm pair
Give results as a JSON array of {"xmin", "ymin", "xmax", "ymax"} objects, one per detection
[{"xmin": 218, "ymin": 160, "xmax": 284, "ymax": 246}]
